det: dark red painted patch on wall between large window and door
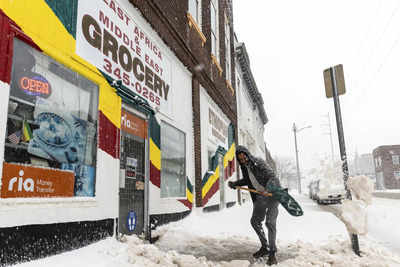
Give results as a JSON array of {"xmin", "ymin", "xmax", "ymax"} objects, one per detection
[{"xmin": 99, "ymin": 111, "xmax": 119, "ymax": 159}]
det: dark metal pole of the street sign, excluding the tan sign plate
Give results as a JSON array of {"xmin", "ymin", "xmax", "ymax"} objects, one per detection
[{"xmin": 329, "ymin": 67, "xmax": 361, "ymax": 256}]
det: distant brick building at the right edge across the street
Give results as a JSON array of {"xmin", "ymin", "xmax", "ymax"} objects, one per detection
[{"xmin": 373, "ymin": 145, "xmax": 400, "ymax": 190}]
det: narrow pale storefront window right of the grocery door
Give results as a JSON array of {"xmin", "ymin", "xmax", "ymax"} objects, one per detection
[{"xmin": 161, "ymin": 122, "xmax": 186, "ymax": 198}]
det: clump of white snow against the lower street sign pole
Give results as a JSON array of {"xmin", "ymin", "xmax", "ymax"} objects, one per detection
[{"xmin": 339, "ymin": 175, "xmax": 374, "ymax": 235}]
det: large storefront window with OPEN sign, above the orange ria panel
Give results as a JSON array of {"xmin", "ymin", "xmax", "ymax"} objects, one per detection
[{"xmin": 4, "ymin": 39, "xmax": 98, "ymax": 196}]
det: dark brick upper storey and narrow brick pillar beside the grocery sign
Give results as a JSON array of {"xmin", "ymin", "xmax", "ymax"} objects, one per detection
[{"xmin": 129, "ymin": 0, "xmax": 237, "ymax": 206}]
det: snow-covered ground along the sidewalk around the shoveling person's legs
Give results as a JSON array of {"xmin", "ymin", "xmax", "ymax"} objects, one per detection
[{"xmin": 12, "ymin": 193, "xmax": 400, "ymax": 267}]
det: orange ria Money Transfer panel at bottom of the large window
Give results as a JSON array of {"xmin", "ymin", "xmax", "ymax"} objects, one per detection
[{"xmin": 0, "ymin": 162, "xmax": 74, "ymax": 198}]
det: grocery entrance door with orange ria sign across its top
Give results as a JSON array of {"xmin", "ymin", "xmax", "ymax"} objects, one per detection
[{"xmin": 119, "ymin": 110, "xmax": 147, "ymax": 235}]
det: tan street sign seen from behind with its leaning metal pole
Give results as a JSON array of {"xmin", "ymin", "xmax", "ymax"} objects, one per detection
[{"xmin": 324, "ymin": 64, "xmax": 361, "ymax": 256}]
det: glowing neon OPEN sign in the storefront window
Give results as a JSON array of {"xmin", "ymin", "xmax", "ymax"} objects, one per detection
[{"xmin": 18, "ymin": 75, "xmax": 51, "ymax": 98}]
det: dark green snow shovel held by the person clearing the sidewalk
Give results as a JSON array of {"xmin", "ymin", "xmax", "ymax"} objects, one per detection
[{"xmin": 236, "ymin": 186, "xmax": 303, "ymax": 217}]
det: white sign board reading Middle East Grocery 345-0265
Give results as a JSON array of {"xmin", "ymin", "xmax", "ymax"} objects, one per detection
[{"xmin": 76, "ymin": 0, "xmax": 172, "ymax": 114}]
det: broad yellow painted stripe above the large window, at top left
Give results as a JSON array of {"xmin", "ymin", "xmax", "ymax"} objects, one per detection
[{"xmin": 0, "ymin": 0, "xmax": 121, "ymax": 128}]
